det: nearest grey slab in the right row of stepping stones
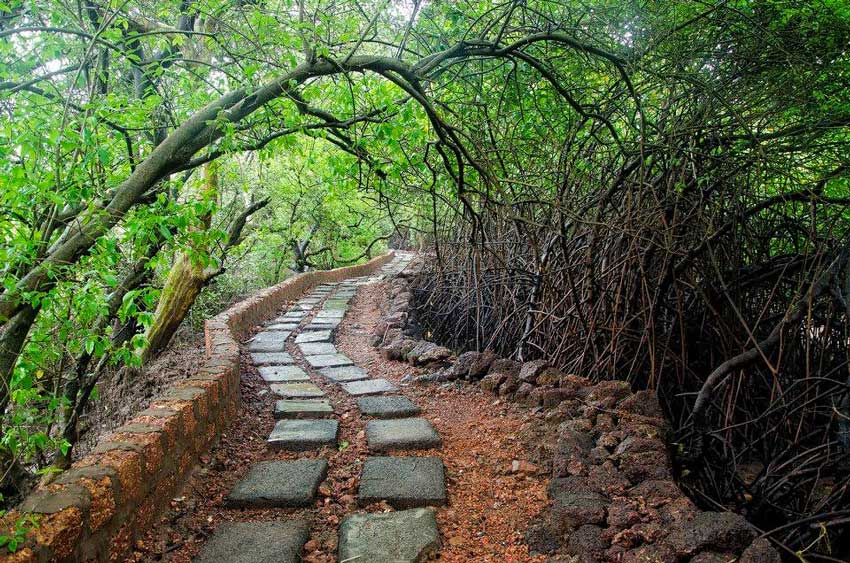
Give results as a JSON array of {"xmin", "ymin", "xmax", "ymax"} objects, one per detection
[{"xmin": 339, "ymin": 508, "xmax": 440, "ymax": 563}]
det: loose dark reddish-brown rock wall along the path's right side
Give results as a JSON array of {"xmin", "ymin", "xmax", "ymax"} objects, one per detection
[{"xmin": 374, "ymin": 265, "xmax": 780, "ymax": 563}]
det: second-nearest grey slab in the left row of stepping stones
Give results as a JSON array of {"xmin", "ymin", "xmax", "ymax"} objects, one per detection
[{"xmin": 225, "ymin": 459, "xmax": 328, "ymax": 508}]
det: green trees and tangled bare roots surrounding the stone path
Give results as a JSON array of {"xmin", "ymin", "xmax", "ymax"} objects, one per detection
[{"xmin": 0, "ymin": 0, "xmax": 850, "ymax": 560}]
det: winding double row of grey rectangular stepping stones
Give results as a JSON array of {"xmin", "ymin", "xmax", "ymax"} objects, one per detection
[{"xmin": 196, "ymin": 253, "xmax": 446, "ymax": 563}]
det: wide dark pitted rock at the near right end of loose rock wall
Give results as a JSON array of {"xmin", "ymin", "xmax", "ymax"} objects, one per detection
[{"xmin": 668, "ymin": 512, "xmax": 755, "ymax": 556}]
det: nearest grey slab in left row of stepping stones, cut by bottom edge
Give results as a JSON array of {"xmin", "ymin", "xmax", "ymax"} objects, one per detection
[{"xmin": 193, "ymin": 520, "xmax": 310, "ymax": 563}]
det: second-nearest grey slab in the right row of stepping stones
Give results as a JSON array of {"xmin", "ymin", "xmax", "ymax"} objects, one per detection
[{"xmin": 358, "ymin": 457, "xmax": 446, "ymax": 508}]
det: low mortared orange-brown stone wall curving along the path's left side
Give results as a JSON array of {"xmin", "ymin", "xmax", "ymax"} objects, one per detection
[{"xmin": 0, "ymin": 252, "xmax": 393, "ymax": 563}]
